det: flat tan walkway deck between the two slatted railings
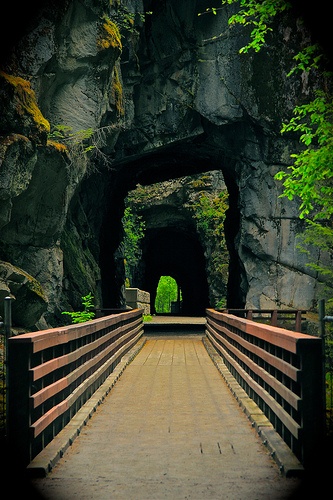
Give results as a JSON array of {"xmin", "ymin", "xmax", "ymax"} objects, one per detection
[{"xmin": 30, "ymin": 318, "xmax": 301, "ymax": 500}]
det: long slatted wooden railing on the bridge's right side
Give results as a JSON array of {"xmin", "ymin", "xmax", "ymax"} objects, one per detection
[{"xmin": 206, "ymin": 309, "xmax": 325, "ymax": 467}]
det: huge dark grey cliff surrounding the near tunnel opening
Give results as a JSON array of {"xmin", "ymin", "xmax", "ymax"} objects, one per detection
[{"xmin": 0, "ymin": 0, "xmax": 328, "ymax": 329}]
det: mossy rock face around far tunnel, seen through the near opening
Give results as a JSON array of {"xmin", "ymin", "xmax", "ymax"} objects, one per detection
[{"xmin": 120, "ymin": 170, "xmax": 229, "ymax": 315}]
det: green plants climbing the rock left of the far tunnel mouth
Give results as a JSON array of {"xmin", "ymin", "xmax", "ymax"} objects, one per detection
[{"xmin": 122, "ymin": 206, "xmax": 146, "ymax": 286}]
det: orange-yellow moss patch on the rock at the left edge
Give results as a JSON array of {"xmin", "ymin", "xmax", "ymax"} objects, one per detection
[{"xmin": 0, "ymin": 71, "xmax": 50, "ymax": 132}]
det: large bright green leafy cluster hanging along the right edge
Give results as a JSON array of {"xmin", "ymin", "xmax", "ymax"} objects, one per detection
[{"xmin": 275, "ymin": 91, "xmax": 333, "ymax": 304}]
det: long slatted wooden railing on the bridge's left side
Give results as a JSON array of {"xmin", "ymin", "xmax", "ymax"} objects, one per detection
[{"xmin": 8, "ymin": 309, "xmax": 143, "ymax": 466}]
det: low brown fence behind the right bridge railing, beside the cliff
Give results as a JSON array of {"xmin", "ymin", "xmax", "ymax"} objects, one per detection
[{"xmin": 217, "ymin": 309, "xmax": 308, "ymax": 332}]
